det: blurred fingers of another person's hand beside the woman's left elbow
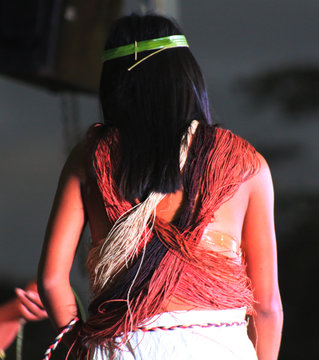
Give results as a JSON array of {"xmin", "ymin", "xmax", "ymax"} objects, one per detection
[{"xmin": 15, "ymin": 282, "xmax": 48, "ymax": 321}]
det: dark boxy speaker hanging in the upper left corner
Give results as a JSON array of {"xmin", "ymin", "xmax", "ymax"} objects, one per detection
[{"xmin": 0, "ymin": 0, "xmax": 122, "ymax": 93}]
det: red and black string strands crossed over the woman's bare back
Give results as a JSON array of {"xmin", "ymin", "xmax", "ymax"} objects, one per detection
[{"xmin": 80, "ymin": 125, "xmax": 258, "ymax": 351}]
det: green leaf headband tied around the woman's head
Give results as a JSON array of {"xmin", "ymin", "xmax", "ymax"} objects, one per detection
[{"xmin": 102, "ymin": 35, "xmax": 188, "ymax": 71}]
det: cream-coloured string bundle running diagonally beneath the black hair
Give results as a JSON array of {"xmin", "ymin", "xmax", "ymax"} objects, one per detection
[{"xmin": 87, "ymin": 120, "xmax": 198, "ymax": 296}]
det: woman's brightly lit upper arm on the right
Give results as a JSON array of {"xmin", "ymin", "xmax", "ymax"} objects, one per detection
[{"xmin": 242, "ymin": 154, "xmax": 280, "ymax": 312}]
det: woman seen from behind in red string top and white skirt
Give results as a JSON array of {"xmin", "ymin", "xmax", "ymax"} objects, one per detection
[{"xmin": 39, "ymin": 15, "xmax": 282, "ymax": 360}]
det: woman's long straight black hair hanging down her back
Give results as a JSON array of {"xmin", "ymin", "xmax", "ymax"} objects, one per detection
[{"xmin": 99, "ymin": 14, "xmax": 212, "ymax": 201}]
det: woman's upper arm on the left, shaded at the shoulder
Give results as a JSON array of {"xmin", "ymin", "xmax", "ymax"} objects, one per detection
[{"xmin": 39, "ymin": 146, "xmax": 86, "ymax": 287}]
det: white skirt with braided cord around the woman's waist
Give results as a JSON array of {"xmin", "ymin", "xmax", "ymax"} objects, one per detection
[{"xmin": 92, "ymin": 308, "xmax": 257, "ymax": 360}]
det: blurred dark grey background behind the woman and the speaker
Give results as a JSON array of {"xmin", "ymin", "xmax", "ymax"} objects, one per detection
[{"xmin": 0, "ymin": 0, "xmax": 319, "ymax": 360}]
